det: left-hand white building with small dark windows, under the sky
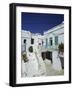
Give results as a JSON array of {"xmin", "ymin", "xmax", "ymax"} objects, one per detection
[{"xmin": 21, "ymin": 30, "xmax": 42, "ymax": 52}]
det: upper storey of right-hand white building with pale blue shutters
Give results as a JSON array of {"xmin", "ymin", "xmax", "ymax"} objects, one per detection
[{"xmin": 43, "ymin": 23, "xmax": 64, "ymax": 50}]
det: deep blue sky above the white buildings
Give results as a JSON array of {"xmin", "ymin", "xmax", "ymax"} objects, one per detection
[{"xmin": 21, "ymin": 12, "xmax": 64, "ymax": 34}]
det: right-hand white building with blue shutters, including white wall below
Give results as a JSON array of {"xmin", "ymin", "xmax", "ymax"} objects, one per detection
[{"xmin": 42, "ymin": 22, "xmax": 64, "ymax": 70}]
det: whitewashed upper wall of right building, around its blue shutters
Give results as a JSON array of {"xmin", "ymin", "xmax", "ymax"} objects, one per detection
[{"xmin": 43, "ymin": 22, "xmax": 64, "ymax": 47}]
